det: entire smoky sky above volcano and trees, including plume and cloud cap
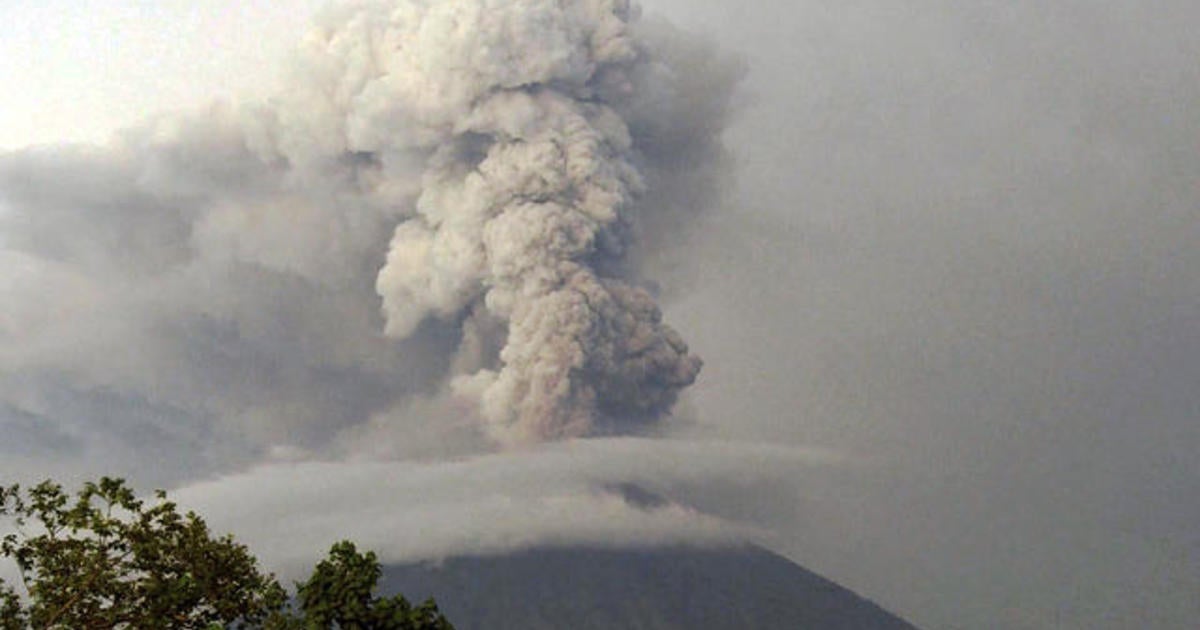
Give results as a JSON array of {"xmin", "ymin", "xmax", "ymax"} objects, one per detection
[{"xmin": 0, "ymin": 0, "xmax": 1200, "ymax": 629}]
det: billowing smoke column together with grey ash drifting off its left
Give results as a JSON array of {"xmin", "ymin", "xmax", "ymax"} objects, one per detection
[{"xmin": 0, "ymin": 0, "xmax": 740, "ymax": 468}]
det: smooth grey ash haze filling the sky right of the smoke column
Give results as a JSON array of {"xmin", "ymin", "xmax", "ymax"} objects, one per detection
[{"xmin": 666, "ymin": 1, "xmax": 1200, "ymax": 628}]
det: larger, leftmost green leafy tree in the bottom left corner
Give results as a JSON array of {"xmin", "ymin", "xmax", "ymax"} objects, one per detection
[{"xmin": 0, "ymin": 478, "xmax": 286, "ymax": 630}]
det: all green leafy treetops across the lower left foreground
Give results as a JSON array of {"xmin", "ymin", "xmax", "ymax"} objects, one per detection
[{"xmin": 0, "ymin": 478, "xmax": 452, "ymax": 630}]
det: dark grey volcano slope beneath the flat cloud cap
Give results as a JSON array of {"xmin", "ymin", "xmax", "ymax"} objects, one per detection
[{"xmin": 382, "ymin": 546, "xmax": 914, "ymax": 630}]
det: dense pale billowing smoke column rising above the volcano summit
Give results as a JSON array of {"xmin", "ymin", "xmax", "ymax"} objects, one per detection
[{"xmin": 297, "ymin": 0, "xmax": 701, "ymax": 442}]
